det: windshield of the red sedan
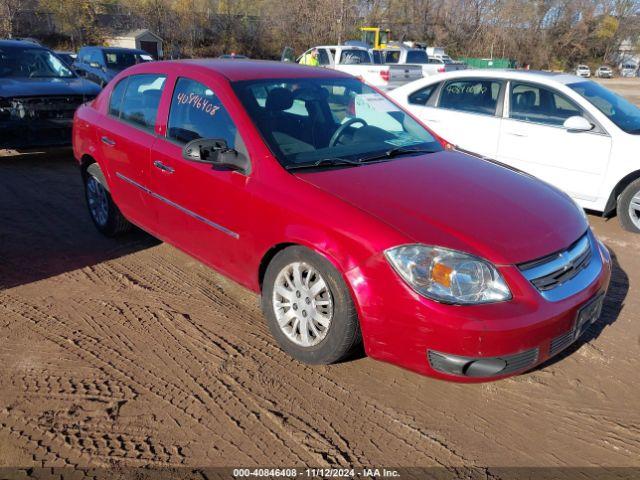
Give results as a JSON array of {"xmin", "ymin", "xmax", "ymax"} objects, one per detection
[{"xmin": 233, "ymin": 78, "xmax": 442, "ymax": 168}]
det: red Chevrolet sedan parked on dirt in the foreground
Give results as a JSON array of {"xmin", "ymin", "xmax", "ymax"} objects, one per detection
[{"xmin": 73, "ymin": 60, "xmax": 611, "ymax": 381}]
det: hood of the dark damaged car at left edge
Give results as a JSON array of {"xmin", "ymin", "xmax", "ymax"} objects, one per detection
[{"xmin": 0, "ymin": 77, "xmax": 100, "ymax": 98}]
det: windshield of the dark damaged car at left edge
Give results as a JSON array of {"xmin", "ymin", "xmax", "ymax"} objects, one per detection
[{"xmin": 0, "ymin": 47, "xmax": 75, "ymax": 78}]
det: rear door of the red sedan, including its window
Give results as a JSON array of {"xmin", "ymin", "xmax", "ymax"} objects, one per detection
[{"xmin": 98, "ymin": 74, "xmax": 166, "ymax": 231}]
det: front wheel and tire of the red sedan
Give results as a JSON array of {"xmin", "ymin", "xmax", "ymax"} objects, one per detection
[{"xmin": 261, "ymin": 246, "xmax": 362, "ymax": 365}]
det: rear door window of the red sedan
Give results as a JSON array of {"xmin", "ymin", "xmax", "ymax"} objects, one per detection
[{"xmin": 117, "ymin": 74, "xmax": 166, "ymax": 131}]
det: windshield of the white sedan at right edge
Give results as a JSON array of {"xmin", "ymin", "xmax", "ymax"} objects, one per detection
[{"xmin": 569, "ymin": 81, "xmax": 640, "ymax": 135}]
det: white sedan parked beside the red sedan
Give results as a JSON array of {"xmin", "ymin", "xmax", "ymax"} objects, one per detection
[{"xmin": 389, "ymin": 70, "xmax": 640, "ymax": 233}]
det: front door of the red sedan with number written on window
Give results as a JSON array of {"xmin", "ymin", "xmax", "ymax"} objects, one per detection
[{"xmin": 151, "ymin": 77, "xmax": 251, "ymax": 276}]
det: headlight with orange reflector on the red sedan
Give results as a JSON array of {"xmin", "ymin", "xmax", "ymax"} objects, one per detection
[{"xmin": 385, "ymin": 245, "xmax": 511, "ymax": 305}]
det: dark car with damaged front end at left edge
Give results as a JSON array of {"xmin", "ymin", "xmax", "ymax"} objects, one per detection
[{"xmin": 0, "ymin": 40, "xmax": 100, "ymax": 149}]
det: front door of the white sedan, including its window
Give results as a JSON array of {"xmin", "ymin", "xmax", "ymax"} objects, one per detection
[{"xmin": 498, "ymin": 81, "xmax": 611, "ymax": 202}]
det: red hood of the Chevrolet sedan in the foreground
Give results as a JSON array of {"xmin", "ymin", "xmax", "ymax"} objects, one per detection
[{"xmin": 296, "ymin": 151, "xmax": 588, "ymax": 264}]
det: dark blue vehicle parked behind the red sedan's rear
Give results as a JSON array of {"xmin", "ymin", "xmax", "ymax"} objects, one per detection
[{"xmin": 73, "ymin": 47, "xmax": 153, "ymax": 87}]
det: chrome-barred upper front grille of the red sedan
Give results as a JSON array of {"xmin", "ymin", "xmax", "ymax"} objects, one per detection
[{"xmin": 518, "ymin": 234, "xmax": 593, "ymax": 292}]
